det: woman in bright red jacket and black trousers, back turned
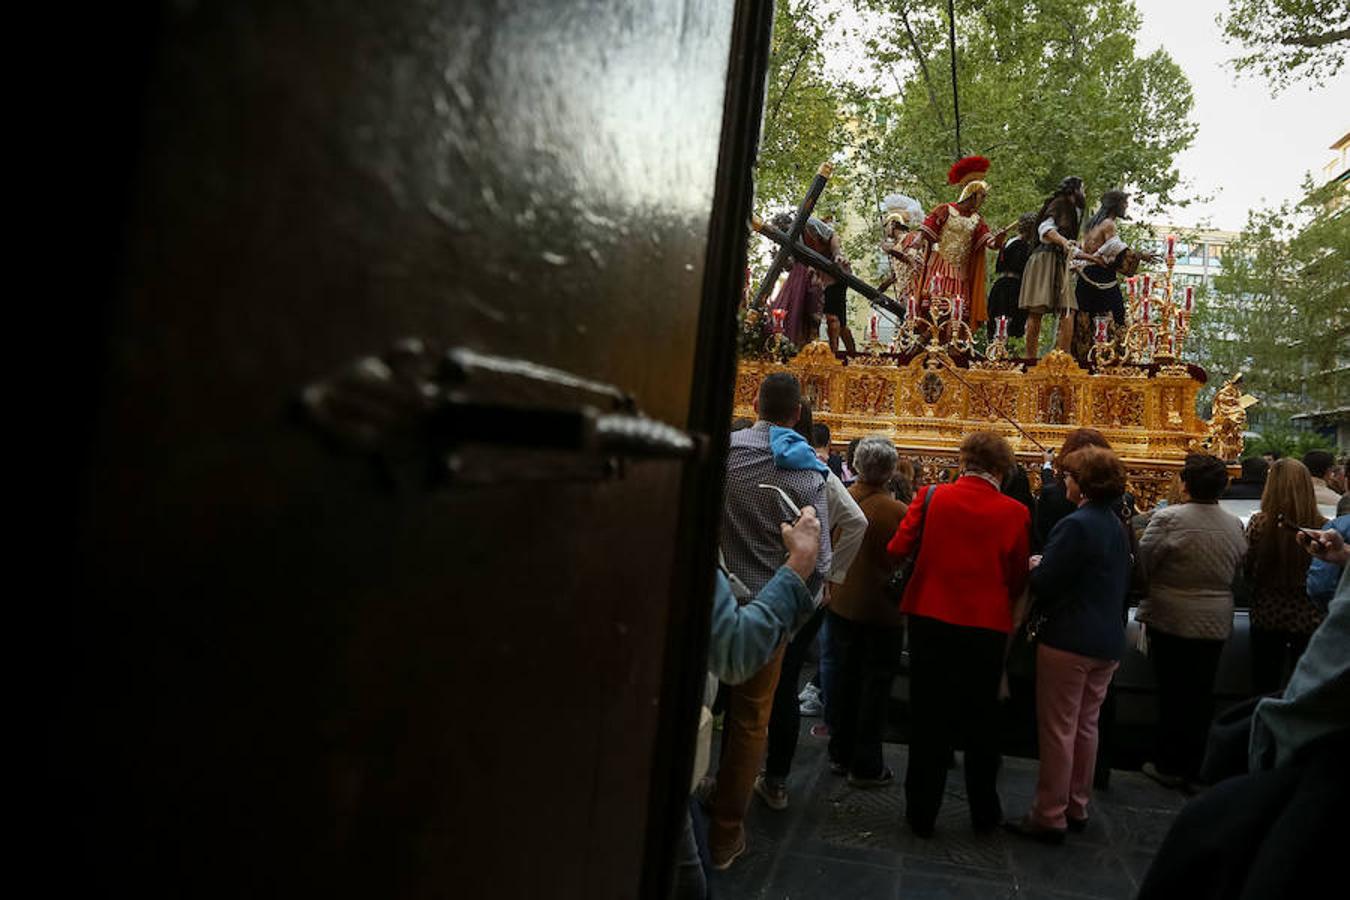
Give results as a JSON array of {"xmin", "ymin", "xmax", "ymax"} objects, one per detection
[{"xmin": 887, "ymin": 432, "xmax": 1031, "ymax": 838}]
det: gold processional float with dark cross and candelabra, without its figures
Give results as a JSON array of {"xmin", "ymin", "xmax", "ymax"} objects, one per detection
[{"xmin": 734, "ymin": 163, "xmax": 1256, "ymax": 510}]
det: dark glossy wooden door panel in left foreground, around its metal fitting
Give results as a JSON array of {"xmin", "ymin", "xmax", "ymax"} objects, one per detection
[{"xmin": 66, "ymin": 0, "xmax": 763, "ymax": 897}]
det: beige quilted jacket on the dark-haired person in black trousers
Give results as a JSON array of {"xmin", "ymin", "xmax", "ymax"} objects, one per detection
[{"xmin": 1137, "ymin": 503, "xmax": 1247, "ymax": 641}]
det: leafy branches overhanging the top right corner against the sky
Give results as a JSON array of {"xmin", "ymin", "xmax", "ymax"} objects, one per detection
[{"xmin": 1218, "ymin": 0, "xmax": 1350, "ymax": 92}]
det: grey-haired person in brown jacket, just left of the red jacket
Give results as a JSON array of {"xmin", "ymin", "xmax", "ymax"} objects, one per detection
[{"xmin": 826, "ymin": 437, "xmax": 906, "ymax": 788}]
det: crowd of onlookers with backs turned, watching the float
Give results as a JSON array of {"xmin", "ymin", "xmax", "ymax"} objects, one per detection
[{"xmin": 678, "ymin": 372, "xmax": 1350, "ymax": 897}]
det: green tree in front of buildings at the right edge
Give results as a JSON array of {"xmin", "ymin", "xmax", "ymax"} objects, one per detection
[{"xmin": 1187, "ymin": 184, "xmax": 1350, "ymax": 421}]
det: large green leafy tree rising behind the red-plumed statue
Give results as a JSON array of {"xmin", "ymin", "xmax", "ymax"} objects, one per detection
[{"xmin": 868, "ymin": 0, "xmax": 1196, "ymax": 236}]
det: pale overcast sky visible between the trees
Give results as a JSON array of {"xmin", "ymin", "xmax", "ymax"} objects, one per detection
[{"xmin": 824, "ymin": 0, "xmax": 1350, "ymax": 231}]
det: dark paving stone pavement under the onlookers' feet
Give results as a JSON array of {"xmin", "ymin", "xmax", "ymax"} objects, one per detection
[{"xmin": 711, "ymin": 719, "xmax": 1185, "ymax": 900}]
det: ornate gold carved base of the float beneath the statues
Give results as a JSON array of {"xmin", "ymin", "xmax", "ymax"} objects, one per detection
[{"xmin": 736, "ymin": 341, "xmax": 1241, "ymax": 510}]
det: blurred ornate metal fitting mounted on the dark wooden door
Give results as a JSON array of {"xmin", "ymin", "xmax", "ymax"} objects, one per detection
[{"xmin": 300, "ymin": 339, "xmax": 706, "ymax": 483}]
